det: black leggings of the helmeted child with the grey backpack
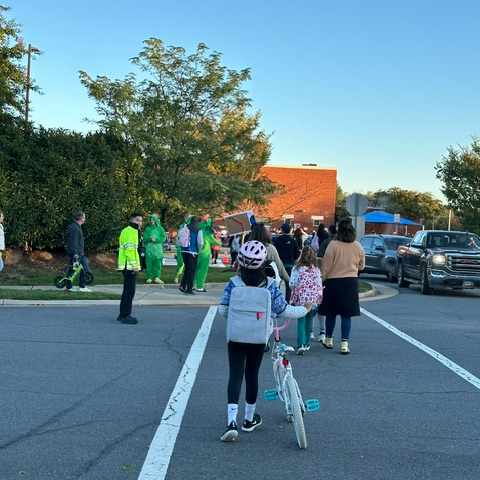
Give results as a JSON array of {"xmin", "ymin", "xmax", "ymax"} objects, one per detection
[{"xmin": 227, "ymin": 342, "xmax": 265, "ymax": 405}]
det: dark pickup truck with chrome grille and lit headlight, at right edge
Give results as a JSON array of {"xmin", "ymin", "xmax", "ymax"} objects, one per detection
[{"xmin": 397, "ymin": 230, "xmax": 480, "ymax": 295}]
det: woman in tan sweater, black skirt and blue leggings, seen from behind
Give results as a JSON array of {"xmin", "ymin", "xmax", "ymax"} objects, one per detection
[{"xmin": 319, "ymin": 218, "xmax": 365, "ymax": 355}]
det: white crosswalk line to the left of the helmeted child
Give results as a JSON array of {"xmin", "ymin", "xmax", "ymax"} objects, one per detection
[{"xmin": 138, "ymin": 307, "xmax": 218, "ymax": 480}]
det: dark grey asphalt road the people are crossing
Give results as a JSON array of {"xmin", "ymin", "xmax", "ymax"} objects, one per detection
[{"xmin": 0, "ymin": 277, "xmax": 480, "ymax": 480}]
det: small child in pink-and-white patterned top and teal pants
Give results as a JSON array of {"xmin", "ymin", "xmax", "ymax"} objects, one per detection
[{"xmin": 290, "ymin": 246, "xmax": 323, "ymax": 355}]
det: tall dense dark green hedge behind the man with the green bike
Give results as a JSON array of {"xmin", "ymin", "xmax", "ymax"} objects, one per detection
[{"xmin": 0, "ymin": 113, "xmax": 127, "ymax": 250}]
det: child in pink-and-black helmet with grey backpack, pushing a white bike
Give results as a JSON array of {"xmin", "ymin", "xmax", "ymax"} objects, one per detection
[{"xmin": 218, "ymin": 240, "xmax": 312, "ymax": 442}]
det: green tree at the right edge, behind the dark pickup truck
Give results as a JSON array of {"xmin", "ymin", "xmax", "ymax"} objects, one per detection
[{"xmin": 435, "ymin": 137, "xmax": 480, "ymax": 232}]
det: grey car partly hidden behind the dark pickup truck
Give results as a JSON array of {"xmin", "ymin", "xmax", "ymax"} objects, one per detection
[{"xmin": 359, "ymin": 234, "xmax": 412, "ymax": 283}]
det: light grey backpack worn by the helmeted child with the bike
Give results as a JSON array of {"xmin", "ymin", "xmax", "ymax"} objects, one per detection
[{"xmin": 227, "ymin": 276, "xmax": 274, "ymax": 345}]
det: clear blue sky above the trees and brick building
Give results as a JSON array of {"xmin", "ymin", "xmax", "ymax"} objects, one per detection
[{"xmin": 7, "ymin": 0, "xmax": 480, "ymax": 199}]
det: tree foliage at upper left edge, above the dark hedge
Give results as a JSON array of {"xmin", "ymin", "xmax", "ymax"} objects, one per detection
[{"xmin": 0, "ymin": 5, "xmax": 39, "ymax": 114}]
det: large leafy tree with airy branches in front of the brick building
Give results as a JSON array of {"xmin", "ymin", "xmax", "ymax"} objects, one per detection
[{"xmin": 80, "ymin": 38, "xmax": 275, "ymax": 224}]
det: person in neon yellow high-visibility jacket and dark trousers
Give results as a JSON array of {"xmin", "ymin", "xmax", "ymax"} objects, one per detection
[{"xmin": 117, "ymin": 212, "xmax": 143, "ymax": 325}]
